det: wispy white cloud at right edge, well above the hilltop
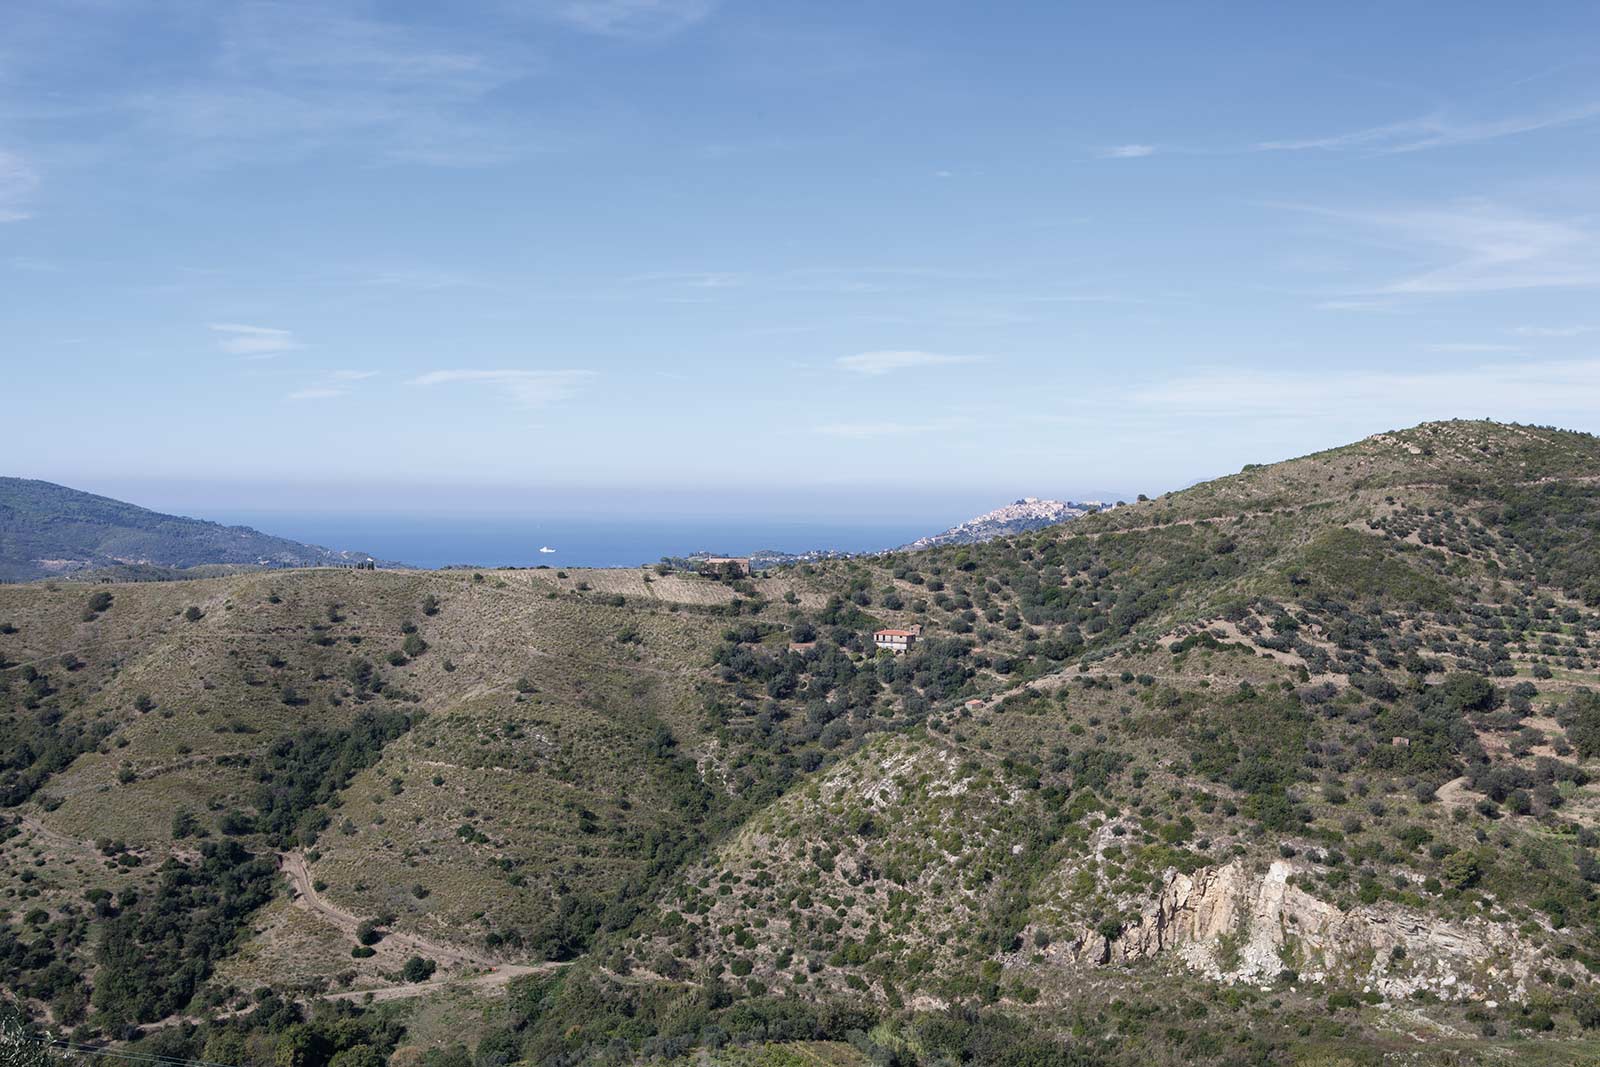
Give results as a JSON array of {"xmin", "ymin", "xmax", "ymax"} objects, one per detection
[{"xmin": 1296, "ymin": 200, "xmax": 1600, "ymax": 296}]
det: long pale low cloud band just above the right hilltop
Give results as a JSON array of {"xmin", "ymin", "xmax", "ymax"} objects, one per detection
[{"xmin": 1126, "ymin": 360, "xmax": 1600, "ymax": 426}]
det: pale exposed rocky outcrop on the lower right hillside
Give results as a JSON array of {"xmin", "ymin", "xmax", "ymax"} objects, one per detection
[{"xmin": 1062, "ymin": 861, "xmax": 1566, "ymax": 1000}]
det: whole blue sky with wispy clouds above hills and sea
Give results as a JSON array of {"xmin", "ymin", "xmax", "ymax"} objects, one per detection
[{"xmin": 0, "ymin": 0, "xmax": 1600, "ymax": 512}]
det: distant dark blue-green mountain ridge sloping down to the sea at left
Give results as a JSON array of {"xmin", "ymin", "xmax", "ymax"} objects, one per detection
[{"xmin": 0, "ymin": 478, "xmax": 387, "ymax": 581}]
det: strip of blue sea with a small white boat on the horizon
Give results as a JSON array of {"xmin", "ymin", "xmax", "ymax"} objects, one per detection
[{"xmin": 198, "ymin": 510, "xmax": 940, "ymax": 568}]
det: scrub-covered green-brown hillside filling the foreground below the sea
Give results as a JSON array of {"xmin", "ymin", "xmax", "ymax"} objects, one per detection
[{"xmin": 9, "ymin": 422, "xmax": 1600, "ymax": 1067}]
